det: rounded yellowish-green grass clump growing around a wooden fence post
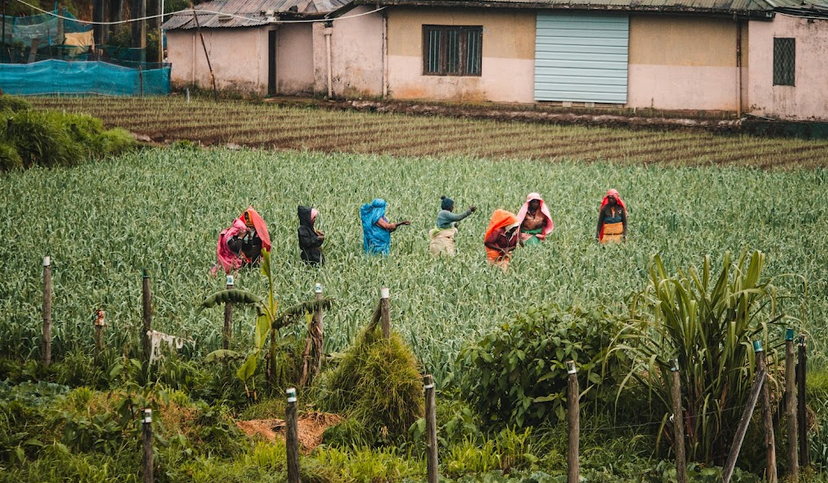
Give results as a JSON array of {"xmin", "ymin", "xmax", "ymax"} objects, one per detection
[{"xmin": 319, "ymin": 327, "xmax": 424, "ymax": 442}]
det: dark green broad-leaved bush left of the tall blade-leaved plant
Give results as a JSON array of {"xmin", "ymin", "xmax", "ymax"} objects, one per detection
[{"xmin": 460, "ymin": 305, "xmax": 626, "ymax": 427}]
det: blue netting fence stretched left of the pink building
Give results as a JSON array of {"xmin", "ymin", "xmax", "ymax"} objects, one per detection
[{"xmin": 0, "ymin": 60, "xmax": 170, "ymax": 96}]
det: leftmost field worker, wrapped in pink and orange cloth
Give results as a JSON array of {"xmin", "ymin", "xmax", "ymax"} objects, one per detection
[{"xmin": 210, "ymin": 206, "xmax": 271, "ymax": 275}]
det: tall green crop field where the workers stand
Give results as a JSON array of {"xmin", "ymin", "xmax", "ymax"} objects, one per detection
[{"xmin": 0, "ymin": 147, "xmax": 828, "ymax": 380}]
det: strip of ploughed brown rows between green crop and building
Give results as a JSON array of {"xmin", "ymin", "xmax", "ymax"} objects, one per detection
[{"xmin": 31, "ymin": 96, "xmax": 828, "ymax": 169}]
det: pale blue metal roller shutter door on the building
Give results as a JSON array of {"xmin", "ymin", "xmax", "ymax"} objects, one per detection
[{"xmin": 535, "ymin": 12, "xmax": 630, "ymax": 104}]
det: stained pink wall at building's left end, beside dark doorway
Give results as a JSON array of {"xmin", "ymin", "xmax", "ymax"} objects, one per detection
[{"xmin": 162, "ymin": 28, "xmax": 267, "ymax": 92}]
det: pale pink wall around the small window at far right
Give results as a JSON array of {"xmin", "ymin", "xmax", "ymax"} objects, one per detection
[{"xmin": 749, "ymin": 13, "xmax": 828, "ymax": 120}]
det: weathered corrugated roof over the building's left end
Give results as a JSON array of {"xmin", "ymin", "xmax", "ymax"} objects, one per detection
[{"xmin": 163, "ymin": 0, "xmax": 350, "ymax": 30}]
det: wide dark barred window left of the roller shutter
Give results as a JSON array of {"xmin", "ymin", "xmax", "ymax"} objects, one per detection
[{"xmin": 423, "ymin": 25, "xmax": 483, "ymax": 76}]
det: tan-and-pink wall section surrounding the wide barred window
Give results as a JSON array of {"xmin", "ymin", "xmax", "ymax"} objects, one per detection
[{"xmin": 388, "ymin": 8, "xmax": 535, "ymax": 102}]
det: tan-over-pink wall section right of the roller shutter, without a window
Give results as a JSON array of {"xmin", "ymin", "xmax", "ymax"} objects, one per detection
[{"xmin": 627, "ymin": 15, "xmax": 748, "ymax": 111}]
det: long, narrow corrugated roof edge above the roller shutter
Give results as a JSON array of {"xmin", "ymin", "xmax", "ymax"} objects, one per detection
[{"xmin": 353, "ymin": 0, "xmax": 796, "ymax": 17}]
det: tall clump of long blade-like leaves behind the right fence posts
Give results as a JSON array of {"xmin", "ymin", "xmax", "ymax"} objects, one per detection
[{"xmin": 612, "ymin": 250, "xmax": 780, "ymax": 463}]
